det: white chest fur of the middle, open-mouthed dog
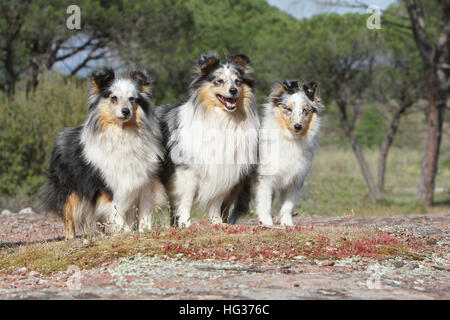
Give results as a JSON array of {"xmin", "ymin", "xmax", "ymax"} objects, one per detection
[{"xmin": 173, "ymin": 103, "xmax": 259, "ymax": 205}]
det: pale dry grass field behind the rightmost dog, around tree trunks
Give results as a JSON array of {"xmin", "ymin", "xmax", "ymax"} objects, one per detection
[{"xmin": 282, "ymin": 147, "xmax": 450, "ymax": 216}]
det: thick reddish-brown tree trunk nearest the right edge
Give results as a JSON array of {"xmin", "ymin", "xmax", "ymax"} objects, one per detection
[{"xmin": 417, "ymin": 65, "xmax": 448, "ymax": 206}]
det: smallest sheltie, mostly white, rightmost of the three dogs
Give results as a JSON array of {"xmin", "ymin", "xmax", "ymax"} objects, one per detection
[{"xmin": 229, "ymin": 80, "xmax": 323, "ymax": 226}]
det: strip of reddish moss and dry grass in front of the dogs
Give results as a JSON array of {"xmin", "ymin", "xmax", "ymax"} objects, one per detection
[{"xmin": 0, "ymin": 221, "xmax": 426, "ymax": 274}]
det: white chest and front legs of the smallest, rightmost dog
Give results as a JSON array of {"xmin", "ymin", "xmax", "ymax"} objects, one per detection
[{"xmin": 251, "ymin": 105, "xmax": 320, "ymax": 226}]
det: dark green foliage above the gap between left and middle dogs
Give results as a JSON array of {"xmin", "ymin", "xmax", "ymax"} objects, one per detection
[{"xmin": 103, "ymin": 0, "xmax": 198, "ymax": 104}]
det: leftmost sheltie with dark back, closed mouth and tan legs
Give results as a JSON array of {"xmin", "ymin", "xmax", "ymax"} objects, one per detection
[{"xmin": 41, "ymin": 69, "xmax": 164, "ymax": 239}]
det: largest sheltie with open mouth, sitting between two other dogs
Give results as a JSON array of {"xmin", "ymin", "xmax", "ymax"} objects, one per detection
[{"xmin": 156, "ymin": 52, "xmax": 259, "ymax": 226}]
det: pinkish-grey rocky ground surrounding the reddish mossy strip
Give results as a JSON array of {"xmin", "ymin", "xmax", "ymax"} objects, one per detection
[{"xmin": 0, "ymin": 210, "xmax": 450, "ymax": 299}]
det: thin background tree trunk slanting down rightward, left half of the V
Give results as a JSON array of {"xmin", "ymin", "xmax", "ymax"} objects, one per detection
[{"xmin": 337, "ymin": 100, "xmax": 381, "ymax": 200}]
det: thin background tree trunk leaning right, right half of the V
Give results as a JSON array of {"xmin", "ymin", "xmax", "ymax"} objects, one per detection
[{"xmin": 377, "ymin": 103, "xmax": 411, "ymax": 193}]
